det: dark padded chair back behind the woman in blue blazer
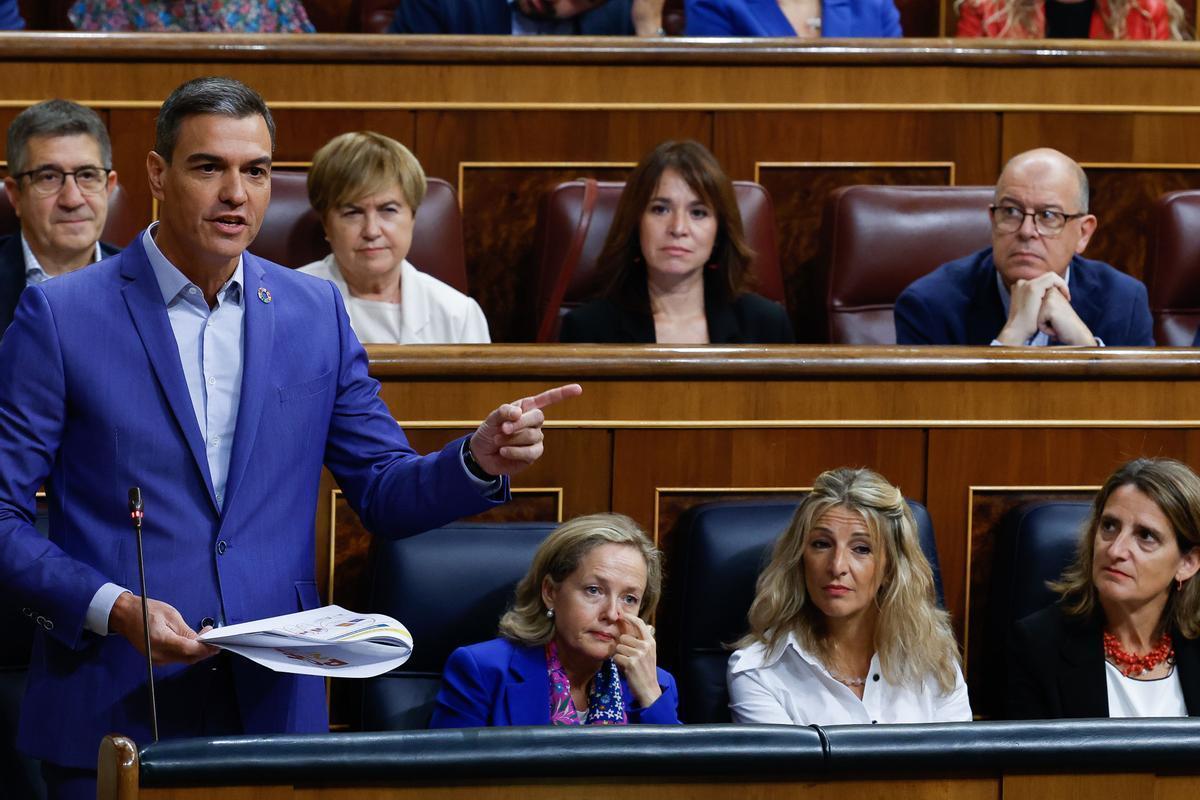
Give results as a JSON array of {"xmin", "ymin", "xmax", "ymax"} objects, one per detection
[{"xmin": 362, "ymin": 522, "xmax": 556, "ymax": 730}]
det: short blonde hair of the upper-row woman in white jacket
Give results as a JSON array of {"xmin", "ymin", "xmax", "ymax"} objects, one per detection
[{"xmin": 308, "ymin": 131, "xmax": 426, "ymax": 219}]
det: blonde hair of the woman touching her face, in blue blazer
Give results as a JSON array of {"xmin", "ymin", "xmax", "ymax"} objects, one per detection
[{"xmin": 500, "ymin": 513, "xmax": 662, "ymax": 646}]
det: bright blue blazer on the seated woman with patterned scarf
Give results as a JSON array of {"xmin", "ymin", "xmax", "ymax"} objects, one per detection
[{"xmin": 430, "ymin": 639, "xmax": 679, "ymax": 728}]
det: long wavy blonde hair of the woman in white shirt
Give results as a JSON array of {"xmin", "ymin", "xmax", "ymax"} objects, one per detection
[{"xmin": 737, "ymin": 468, "xmax": 958, "ymax": 693}]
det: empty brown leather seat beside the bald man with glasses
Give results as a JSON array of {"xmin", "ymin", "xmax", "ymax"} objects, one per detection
[{"xmin": 805, "ymin": 186, "xmax": 994, "ymax": 344}]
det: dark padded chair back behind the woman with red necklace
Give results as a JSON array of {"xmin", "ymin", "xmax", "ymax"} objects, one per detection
[{"xmin": 971, "ymin": 501, "xmax": 1092, "ymax": 717}]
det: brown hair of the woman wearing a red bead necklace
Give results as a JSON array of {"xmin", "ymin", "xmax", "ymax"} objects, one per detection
[{"xmin": 1049, "ymin": 458, "xmax": 1200, "ymax": 639}]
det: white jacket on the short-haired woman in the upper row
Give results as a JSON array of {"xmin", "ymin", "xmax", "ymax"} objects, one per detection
[{"xmin": 300, "ymin": 253, "xmax": 492, "ymax": 344}]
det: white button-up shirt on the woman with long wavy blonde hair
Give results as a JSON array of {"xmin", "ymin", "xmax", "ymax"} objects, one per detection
[{"xmin": 726, "ymin": 633, "xmax": 971, "ymax": 724}]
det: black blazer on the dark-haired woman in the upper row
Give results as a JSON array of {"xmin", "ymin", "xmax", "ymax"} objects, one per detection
[{"xmin": 558, "ymin": 291, "xmax": 796, "ymax": 344}]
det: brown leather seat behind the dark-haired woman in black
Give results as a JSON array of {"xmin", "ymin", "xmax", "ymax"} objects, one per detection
[{"xmin": 534, "ymin": 179, "xmax": 785, "ymax": 342}]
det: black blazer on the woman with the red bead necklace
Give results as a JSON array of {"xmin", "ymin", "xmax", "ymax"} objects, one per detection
[{"xmin": 1004, "ymin": 606, "xmax": 1200, "ymax": 720}]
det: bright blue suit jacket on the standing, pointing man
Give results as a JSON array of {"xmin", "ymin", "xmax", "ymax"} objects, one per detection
[{"xmin": 0, "ymin": 236, "xmax": 501, "ymax": 768}]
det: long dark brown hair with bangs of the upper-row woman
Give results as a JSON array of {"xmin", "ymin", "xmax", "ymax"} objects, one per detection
[{"xmin": 596, "ymin": 140, "xmax": 754, "ymax": 312}]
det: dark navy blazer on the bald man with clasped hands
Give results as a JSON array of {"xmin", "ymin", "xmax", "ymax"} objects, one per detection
[{"xmin": 895, "ymin": 247, "xmax": 1154, "ymax": 347}]
